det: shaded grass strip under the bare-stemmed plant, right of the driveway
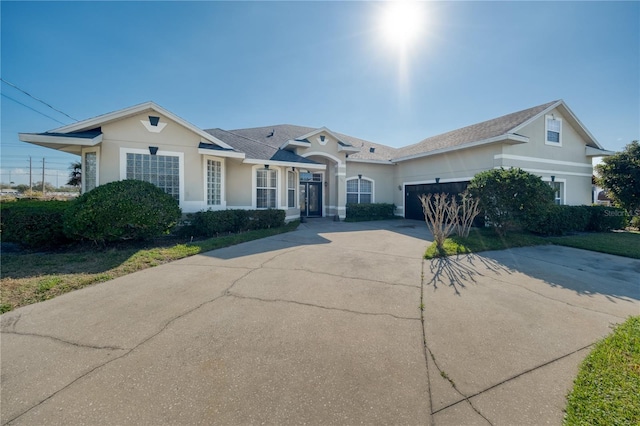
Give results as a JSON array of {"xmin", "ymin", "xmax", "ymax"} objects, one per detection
[{"xmin": 424, "ymin": 228, "xmax": 640, "ymax": 259}]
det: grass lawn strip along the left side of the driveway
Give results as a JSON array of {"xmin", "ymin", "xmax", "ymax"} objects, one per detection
[{"xmin": 0, "ymin": 221, "xmax": 299, "ymax": 313}]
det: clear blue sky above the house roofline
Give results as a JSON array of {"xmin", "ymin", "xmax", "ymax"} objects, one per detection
[{"xmin": 0, "ymin": 1, "xmax": 640, "ymax": 184}]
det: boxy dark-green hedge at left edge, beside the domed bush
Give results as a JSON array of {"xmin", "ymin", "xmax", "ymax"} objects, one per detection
[{"xmin": 0, "ymin": 200, "xmax": 71, "ymax": 248}]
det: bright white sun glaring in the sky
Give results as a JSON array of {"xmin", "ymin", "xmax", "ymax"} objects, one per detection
[{"xmin": 382, "ymin": 0, "xmax": 424, "ymax": 47}]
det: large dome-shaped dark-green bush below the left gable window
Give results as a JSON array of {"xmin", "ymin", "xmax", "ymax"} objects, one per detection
[{"xmin": 64, "ymin": 180, "xmax": 181, "ymax": 243}]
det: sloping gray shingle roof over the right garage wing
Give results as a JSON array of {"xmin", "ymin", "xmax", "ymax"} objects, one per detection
[{"xmin": 395, "ymin": 101, "xmax": 558, "ymax": 158}]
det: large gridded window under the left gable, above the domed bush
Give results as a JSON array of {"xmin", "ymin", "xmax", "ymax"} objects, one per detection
[{"xmin": 126, "ymin": 152, "xmax": 180, "ymax": 202}]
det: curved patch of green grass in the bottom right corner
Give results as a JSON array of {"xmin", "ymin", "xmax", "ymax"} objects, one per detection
[{"xmin": 564, "ymin": 316, "xmax": 640, "ymax": 425}]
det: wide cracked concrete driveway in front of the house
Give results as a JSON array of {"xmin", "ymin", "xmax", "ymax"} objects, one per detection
[{"xmin": 0, "ymin": 220, "xmax": 640, "ymax": 425}]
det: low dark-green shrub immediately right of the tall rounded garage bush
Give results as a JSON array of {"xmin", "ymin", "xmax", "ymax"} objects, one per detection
[{"xmin": 527, "ymin": 204, "xmax": 591, "ymax": 235}]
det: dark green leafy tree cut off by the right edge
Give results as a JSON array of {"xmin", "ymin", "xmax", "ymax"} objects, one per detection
[{"xmin": 596, "ymin": 141, "xmax": 640, "ymax": 212}]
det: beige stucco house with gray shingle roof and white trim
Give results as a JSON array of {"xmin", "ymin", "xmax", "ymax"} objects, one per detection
[{"xmin": 19, "ymin": 100, "xmax": 612, "ymax": 220}]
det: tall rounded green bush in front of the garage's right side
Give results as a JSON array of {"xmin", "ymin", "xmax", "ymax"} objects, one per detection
[{"xmin": 467, "ymin": 168, "xmax": 554, "ymax": 235}]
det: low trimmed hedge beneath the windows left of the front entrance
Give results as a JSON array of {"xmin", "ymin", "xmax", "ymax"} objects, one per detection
[{"xmin": 184, "ymin": 209, "xmax": 285, "ymax": 237}]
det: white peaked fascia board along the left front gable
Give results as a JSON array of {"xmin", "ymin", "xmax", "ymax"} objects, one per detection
[{"xmin": 51, "ymin": 102, "xmax": 232, "ymax": 149}]
